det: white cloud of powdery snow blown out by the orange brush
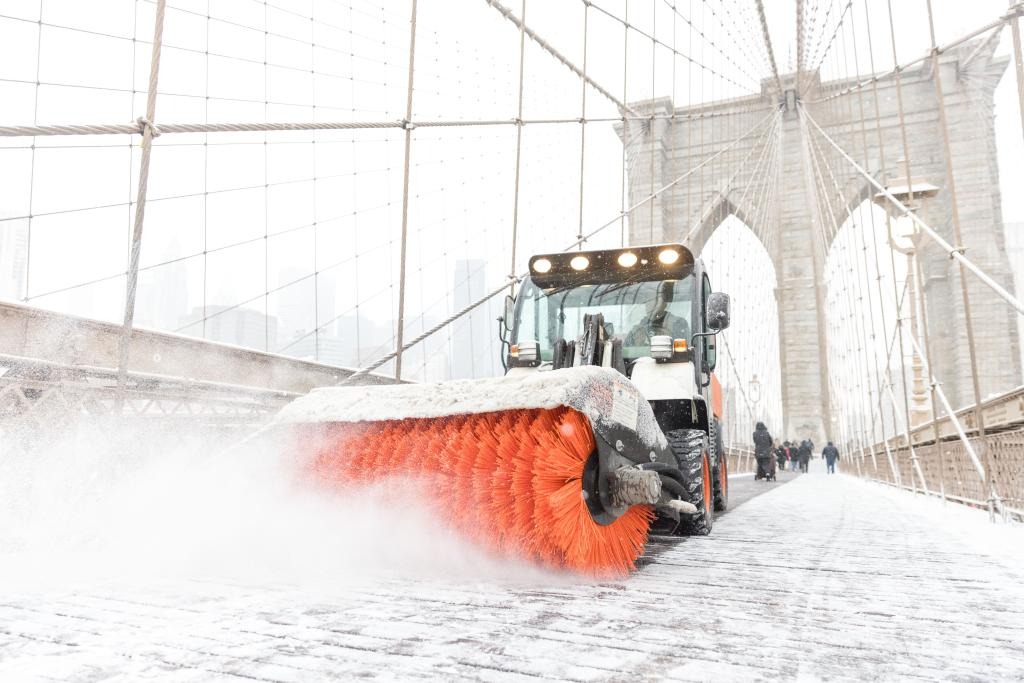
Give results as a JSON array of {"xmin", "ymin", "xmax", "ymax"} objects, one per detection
[{"xmin": 0, "ymin": 413, "xmax": 552, "ymax": 587}]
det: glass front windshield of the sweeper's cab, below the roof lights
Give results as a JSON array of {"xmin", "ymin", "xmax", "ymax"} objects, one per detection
[{"xmin": 513, "ymin": 275, "xmax": 693, "ymax": 361}]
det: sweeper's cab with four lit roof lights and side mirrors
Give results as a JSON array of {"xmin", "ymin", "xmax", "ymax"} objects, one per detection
[{"xmin": 505, "ymin": 245, "xmax": 729, "ymax": 398}]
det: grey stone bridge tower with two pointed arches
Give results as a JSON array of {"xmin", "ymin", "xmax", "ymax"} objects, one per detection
[{"xmin": 618, "ymin": 41, "xmax": 1021, "ymax": 443}]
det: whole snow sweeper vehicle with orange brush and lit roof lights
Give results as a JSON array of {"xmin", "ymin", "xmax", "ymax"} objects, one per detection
[{"xmin": 271, "ymin": 245, "xmax": 729, "ymax": 577}]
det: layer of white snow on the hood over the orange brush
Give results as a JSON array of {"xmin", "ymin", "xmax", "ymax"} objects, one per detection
[{"xmin": 274, "ymin": 366, "xmax": 667, "ymax": 447}]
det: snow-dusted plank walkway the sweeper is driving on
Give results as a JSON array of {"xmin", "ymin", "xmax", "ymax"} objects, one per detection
[{"xmin": 0, "ymin": 473, "xmax": 1024, "ymax": 681}]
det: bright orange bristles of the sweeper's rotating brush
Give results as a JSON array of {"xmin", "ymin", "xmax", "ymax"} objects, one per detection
[{"xmin": 312, "ymin": 408, "xmax": 654, "ymax": 578}]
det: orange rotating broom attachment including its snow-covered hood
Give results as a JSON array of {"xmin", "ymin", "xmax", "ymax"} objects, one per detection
[{"xmin": 279, "ymin": 368, "xmax": 692, "ymax": 578}]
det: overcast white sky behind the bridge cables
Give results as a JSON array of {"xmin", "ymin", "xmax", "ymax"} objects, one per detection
[{"xmin": 0, "ymin": 0, "xmax": 1024, "ymax": 389}]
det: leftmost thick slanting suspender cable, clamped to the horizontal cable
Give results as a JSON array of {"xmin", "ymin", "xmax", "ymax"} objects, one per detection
[{"xmin": 118, "ymin": 0, "xmax": 167, "ymax": 389}]
